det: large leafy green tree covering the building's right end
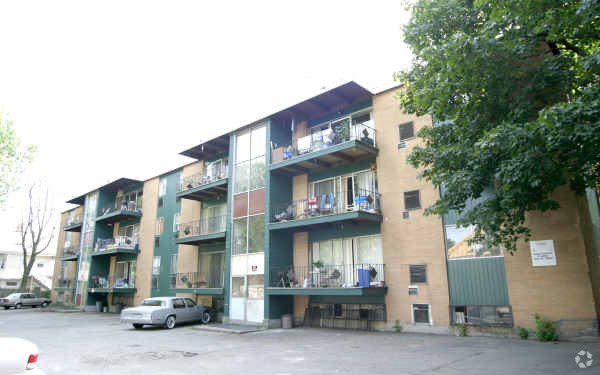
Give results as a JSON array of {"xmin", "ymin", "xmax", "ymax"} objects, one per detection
[{"xmin": 396, "ymin": 0, "xmax": 600, "ymax": 253}]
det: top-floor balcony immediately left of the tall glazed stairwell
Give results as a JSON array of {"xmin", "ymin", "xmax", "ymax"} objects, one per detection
[{"xmin": 176, "ymin": 165, "xmax": 229, "ymax": 201}]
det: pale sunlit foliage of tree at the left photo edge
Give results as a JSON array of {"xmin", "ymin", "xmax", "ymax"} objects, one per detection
[{"xmin": 0, "ymin": 112, "xmax": 37, "ymax": 208}]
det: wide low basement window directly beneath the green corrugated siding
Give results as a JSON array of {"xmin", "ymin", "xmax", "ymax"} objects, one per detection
[{"xmin": 450, "ymin": 305, "xmax": 513, "ymax": 327}]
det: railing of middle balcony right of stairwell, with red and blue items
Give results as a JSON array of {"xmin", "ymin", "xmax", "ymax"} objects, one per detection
[{"xmin": 271, "ymin": 189, "xmax": 381, "ymax": 223}]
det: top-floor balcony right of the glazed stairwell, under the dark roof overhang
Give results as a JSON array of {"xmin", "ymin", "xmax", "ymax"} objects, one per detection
[{"xmin": 269, "ymin": 119, "xmax": 378, "ymax": 175}]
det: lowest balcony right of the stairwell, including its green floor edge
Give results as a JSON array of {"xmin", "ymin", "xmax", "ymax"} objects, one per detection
[{"xmin": 267, "ymin": 264, "xmax": 387, "ymax": 296}]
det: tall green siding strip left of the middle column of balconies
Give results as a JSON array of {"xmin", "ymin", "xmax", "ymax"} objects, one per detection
[{"xmin": 151, "ymin": 170, "xmax": 181, "ymax": 297}]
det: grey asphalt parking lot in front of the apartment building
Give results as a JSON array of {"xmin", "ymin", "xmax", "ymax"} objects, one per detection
[{"xmin": 0, "ymin": 309, "xmax": 600, "ymax": 375}]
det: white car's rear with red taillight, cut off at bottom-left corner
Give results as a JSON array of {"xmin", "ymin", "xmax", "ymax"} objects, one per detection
[{"xmin": 0, "ymin": 337, "xmax": 44, "ymax": 375}]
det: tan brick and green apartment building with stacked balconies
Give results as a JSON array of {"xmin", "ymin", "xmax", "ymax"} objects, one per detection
[{"xmin": 53, "ymin": 82, "xmax": 600, "ymax": 335}]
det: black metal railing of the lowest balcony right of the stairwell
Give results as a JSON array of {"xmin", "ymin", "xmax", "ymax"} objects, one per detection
[{"xmin": 270, "ymin": 264, "xmax": 385, "ymax": 289}]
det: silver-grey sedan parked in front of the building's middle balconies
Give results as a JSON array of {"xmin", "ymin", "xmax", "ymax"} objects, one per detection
[{"xmin": 121, "ymin": 297, "xmax": 211, "ymax": 329}]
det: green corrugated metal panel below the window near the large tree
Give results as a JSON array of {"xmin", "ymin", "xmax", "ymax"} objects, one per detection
[{"xmin": 448, "ymin": 257, "xmax": 509, "ymax": 306}]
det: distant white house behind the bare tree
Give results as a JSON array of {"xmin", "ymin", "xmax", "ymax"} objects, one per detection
[{"xmin": 0, "ymin": 250, "xmax": 55, "ymax": 290}]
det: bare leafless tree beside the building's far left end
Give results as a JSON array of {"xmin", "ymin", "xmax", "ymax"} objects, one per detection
[{"xmin": 17, "ymin": 183, "xmax": 56, "ymax": 289}]
